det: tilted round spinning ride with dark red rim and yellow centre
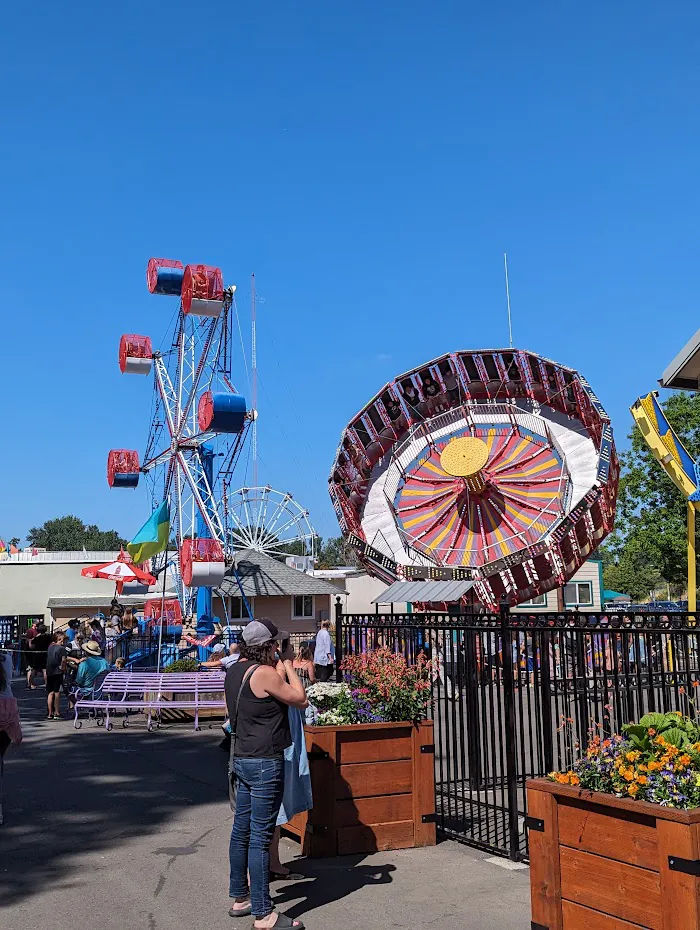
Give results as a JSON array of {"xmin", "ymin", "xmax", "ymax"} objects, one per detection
[{"xmin": 329, "ymin": 349, "xmax": 619, "ymax": 610}]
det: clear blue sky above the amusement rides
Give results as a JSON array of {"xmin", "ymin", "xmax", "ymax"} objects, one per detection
[{"xmin": 0, "ymin": 0, "xmax": 700, "ymax": 538}]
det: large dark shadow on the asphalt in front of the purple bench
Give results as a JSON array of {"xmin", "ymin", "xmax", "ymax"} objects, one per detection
[{"xmin": 0, "ymin": 682, "xmax": 227, "ymax": 904}]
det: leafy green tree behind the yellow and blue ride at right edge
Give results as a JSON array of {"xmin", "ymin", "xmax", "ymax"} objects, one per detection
[{"xmin": 601, "ymin": 394, "xmax": 700, "ymax": 598}]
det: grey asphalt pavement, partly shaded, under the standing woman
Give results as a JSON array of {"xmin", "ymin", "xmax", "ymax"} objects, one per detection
[{"xmin": 0, "ymin": 682, "xmax": 530, "ymax": 930}]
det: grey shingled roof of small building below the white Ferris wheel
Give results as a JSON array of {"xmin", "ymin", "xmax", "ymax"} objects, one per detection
[{"xmin": 219, "ymin": 549, "xmax": 344, "ymax": 597}]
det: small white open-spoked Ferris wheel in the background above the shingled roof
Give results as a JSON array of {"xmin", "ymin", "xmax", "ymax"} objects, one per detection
[{"xmin": 228, "ymin": 485, "xmax": 318, "ymax": 559}]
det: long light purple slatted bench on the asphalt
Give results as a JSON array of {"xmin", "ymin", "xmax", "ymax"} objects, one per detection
[{"xmin": 73, "ymin": 671, "xmax": 226, "ymax": 731}]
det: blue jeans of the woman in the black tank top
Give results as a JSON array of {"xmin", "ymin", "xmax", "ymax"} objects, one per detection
[{"xmin": 228, "ymin": 759, "xmax": 284, "ymax": 920}]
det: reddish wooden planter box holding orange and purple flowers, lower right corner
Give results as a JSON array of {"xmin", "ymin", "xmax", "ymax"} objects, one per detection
[{"xmin": 527, "ymin": 779, "xmax": 700, "ymax": 930}]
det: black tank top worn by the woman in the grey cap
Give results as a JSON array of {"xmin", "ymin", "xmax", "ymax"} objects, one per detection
[{"xmin": 225, "ymin": 659, "xmax": 292, "ymax": 759}]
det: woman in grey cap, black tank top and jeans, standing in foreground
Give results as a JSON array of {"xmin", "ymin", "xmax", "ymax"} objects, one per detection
[{"xmin": 225, "ymin": 619, "xmax": 307, "ymax": 930}]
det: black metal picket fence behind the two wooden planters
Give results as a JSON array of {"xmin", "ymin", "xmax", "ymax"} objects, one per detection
[{"xmin": 336, "ymin": 607, "xmax": 700, "ymax": 860}]
